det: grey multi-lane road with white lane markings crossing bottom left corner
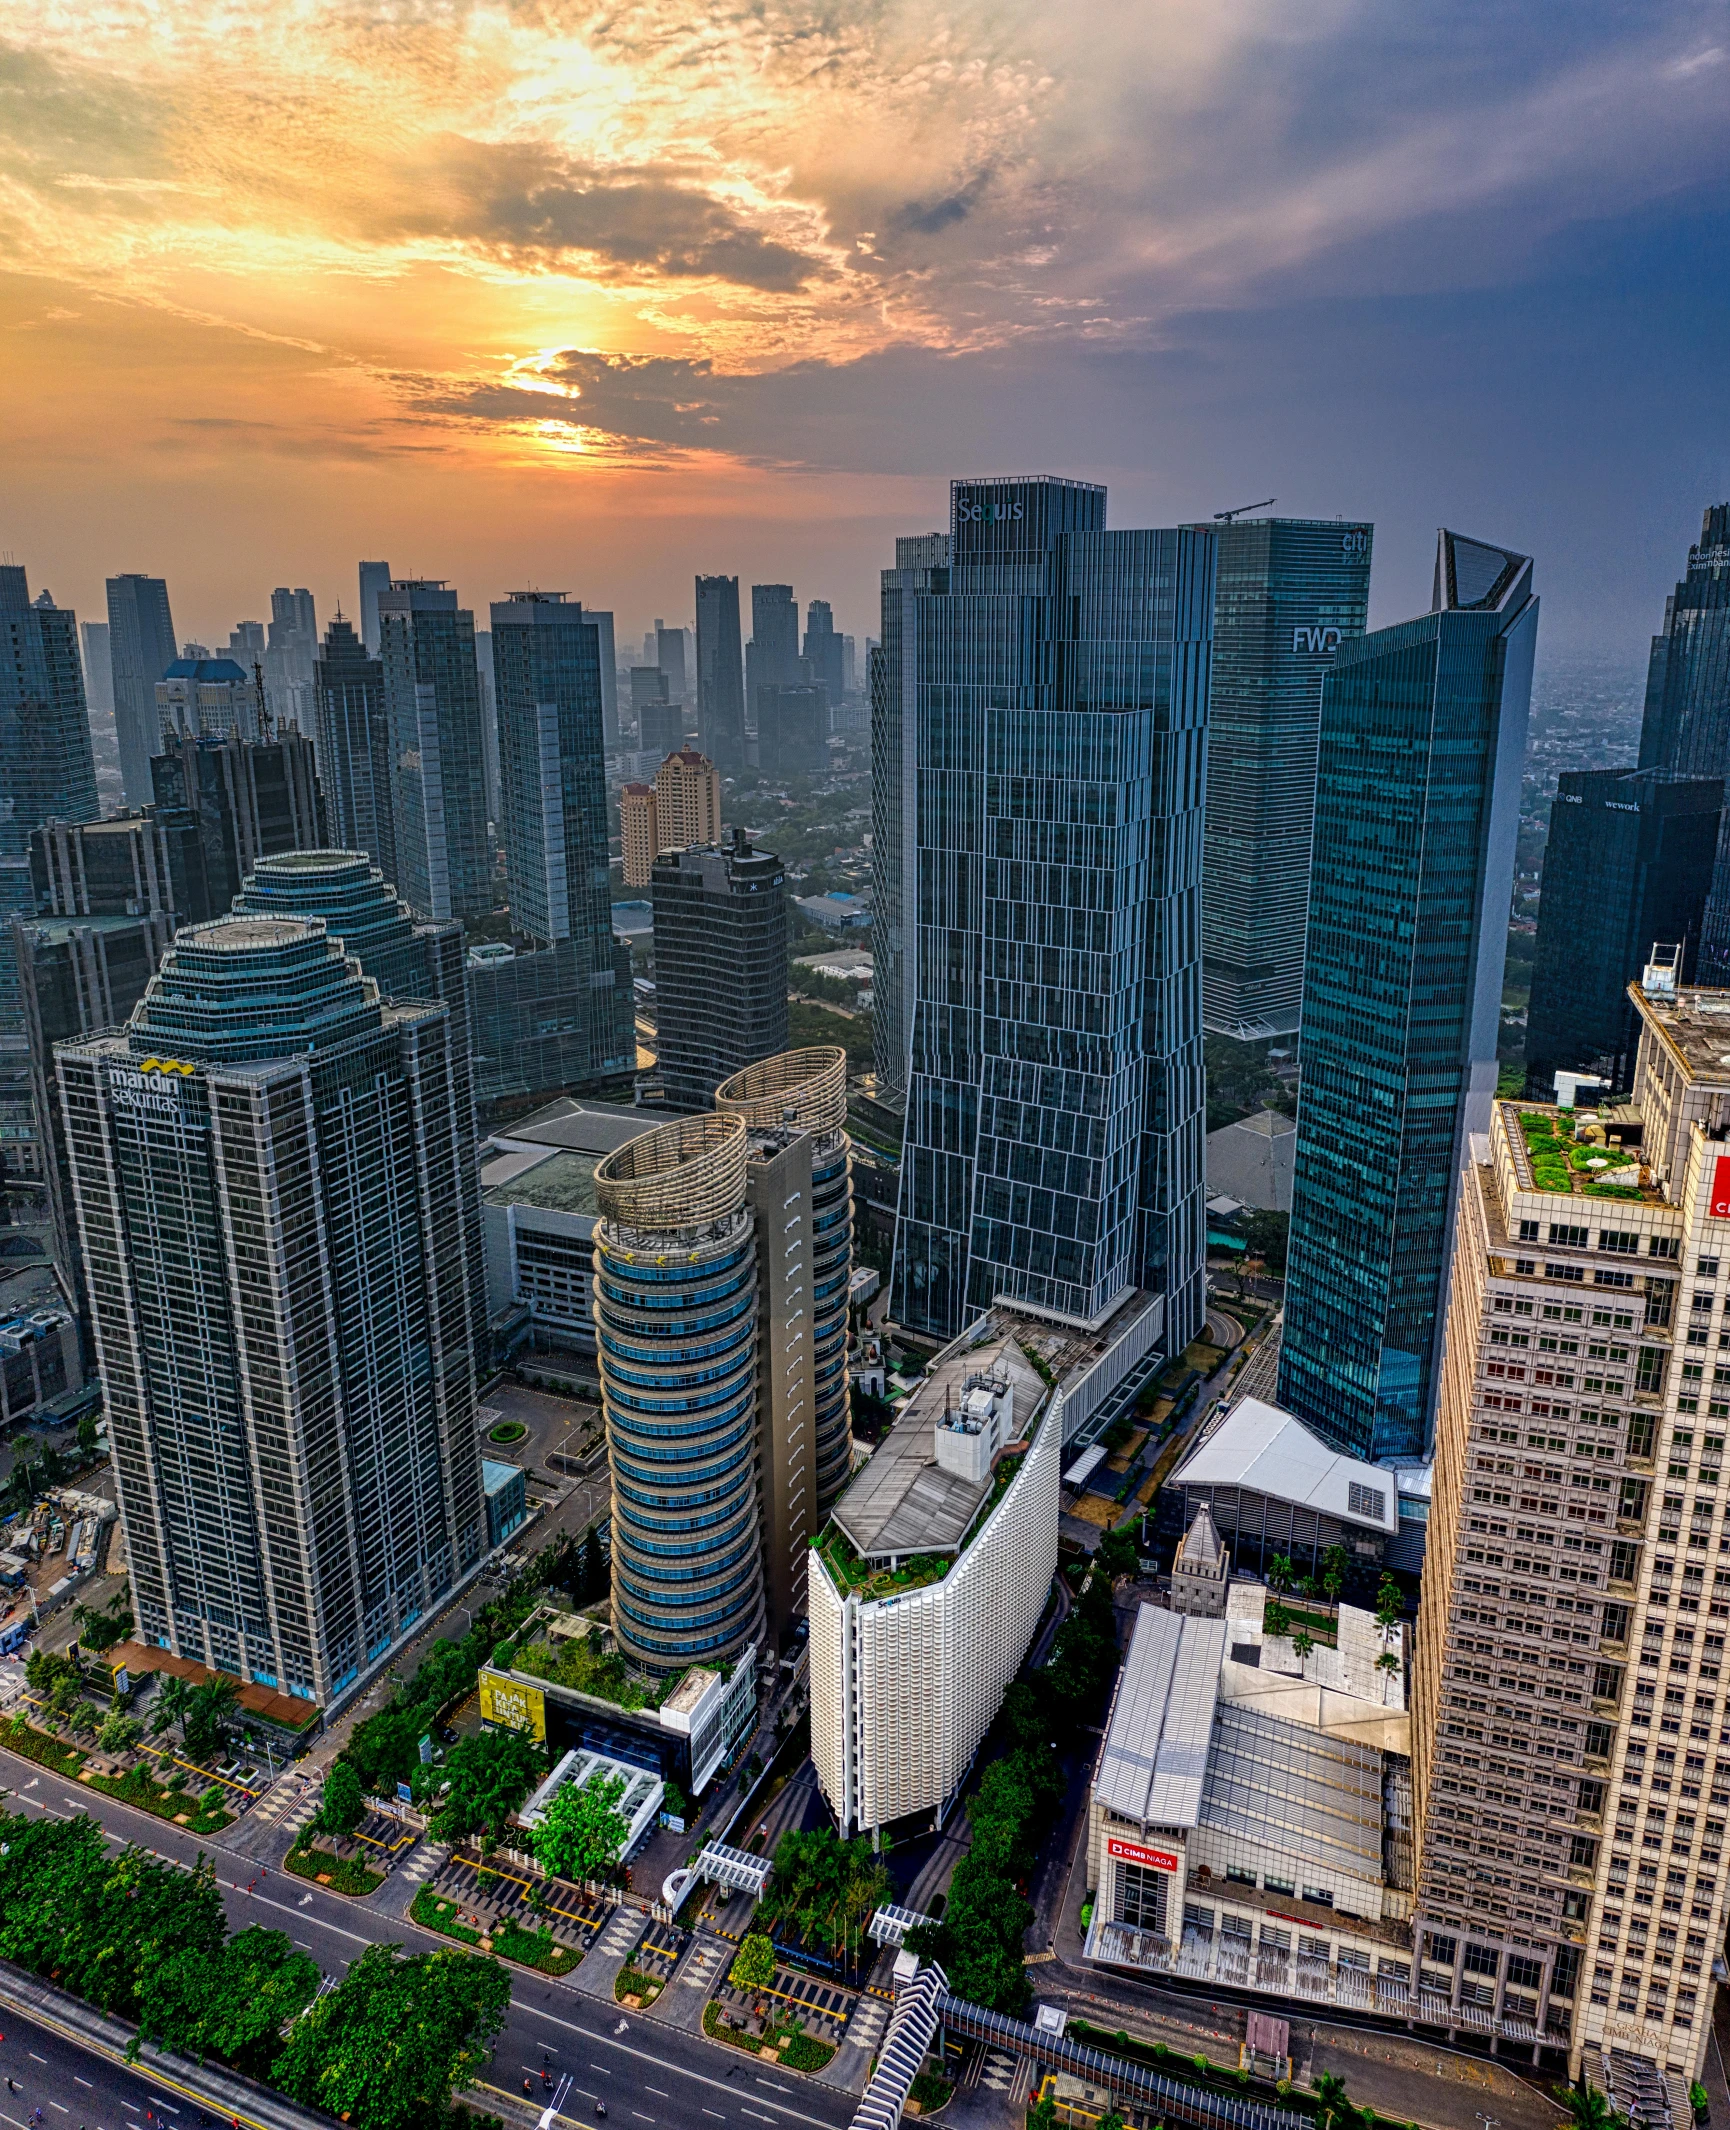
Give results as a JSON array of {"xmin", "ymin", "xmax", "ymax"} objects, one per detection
[{"xmin": 0, "ymin": 1749, "xmax": 854, "ymax": 2130}]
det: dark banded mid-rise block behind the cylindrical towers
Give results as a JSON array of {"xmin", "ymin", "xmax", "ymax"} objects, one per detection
[{"xmin": 652, "ymin": 829, "xmax": 786, "ymax": 1110}]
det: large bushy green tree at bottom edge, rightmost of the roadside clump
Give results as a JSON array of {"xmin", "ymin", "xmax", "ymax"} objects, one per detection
[{"xmin": 273, "ymin": 1945, "xmax": 511, "ymax": 2130}]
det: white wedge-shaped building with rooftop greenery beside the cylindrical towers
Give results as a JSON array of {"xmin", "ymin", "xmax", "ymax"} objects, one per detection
[{"xmin": 810, "ymin": 1312, "xmax": 1063, "ymax": 1836}]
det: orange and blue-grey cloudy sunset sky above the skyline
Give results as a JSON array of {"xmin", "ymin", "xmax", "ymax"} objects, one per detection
[{"xmin": 0, "ymin": 0, "xmax": 1730, "ymax": 658}]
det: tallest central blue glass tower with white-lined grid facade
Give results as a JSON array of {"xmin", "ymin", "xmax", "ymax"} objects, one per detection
[{"xmin": 893, "ymin": 479, "xmax": 1214, "ymax": 1353}]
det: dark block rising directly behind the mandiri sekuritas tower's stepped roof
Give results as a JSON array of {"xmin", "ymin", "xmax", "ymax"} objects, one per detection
[{"xmin": 151, "ymin": 724, "xmax": 328, "ymax": 918}]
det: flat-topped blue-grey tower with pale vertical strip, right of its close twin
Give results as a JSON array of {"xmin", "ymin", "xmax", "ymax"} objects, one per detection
[{"xmin": 492, "ymin": 592, "xmax": 614, "ymax": 945}]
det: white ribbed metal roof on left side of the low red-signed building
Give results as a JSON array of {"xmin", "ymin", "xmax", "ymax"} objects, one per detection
[{"xmin": 1093, "ymin": 1604, "xmax": 1227, "ymax": 1828}]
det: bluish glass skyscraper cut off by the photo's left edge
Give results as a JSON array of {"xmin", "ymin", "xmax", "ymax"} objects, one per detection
[{"xmin": 0, "ymin": 562, "xmax": 98, "ymax": 1035}]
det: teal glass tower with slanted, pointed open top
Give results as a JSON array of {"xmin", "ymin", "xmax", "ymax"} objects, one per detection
[{"xmin": 1278, "ymin": 533, "xmax": 1538, "ymax": 1457}]
